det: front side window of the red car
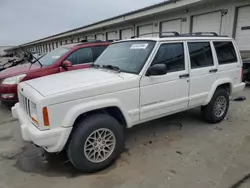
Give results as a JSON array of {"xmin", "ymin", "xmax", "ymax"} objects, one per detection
[{"xmin": 67, "ymin": 48, "xmax": 93, "ymax": 65}]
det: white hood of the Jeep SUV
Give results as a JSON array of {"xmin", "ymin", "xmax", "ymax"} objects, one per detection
[{"xmin": 25, "ymin": 68, "xmax": 133, "ymax": 96}]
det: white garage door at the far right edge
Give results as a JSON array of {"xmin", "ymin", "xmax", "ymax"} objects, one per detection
[{"xmin": 235, "ymin": 6, "xmax": 250, "ymax": 50}]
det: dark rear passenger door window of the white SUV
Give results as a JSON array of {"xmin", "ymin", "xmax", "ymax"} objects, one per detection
[{"xmin": 188, "ymin": 42, "xmax": 214, "ymax": 69}]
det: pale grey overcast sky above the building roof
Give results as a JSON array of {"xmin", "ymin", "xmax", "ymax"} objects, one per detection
[{"xmin": 0, "ymin": 0, "xmax": 163, "ymax": 46}]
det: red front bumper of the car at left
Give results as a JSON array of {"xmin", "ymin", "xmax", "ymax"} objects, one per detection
[{"xmin": 0, "ymin": 84, "xmax": 18, "ymax": 102}]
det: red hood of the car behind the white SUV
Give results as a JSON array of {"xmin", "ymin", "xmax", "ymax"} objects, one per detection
[{"xmin": 0, "ymin": 63, "xmax": 41, "ymax": 79}]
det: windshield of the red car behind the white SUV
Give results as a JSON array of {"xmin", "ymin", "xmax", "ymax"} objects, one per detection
[{"xmin": 36, "ymin": 47, "xmax": 70, "ymax": 66}]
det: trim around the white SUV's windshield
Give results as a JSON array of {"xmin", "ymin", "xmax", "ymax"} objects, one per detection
[{"xmin": 94, "ymin": 39, "xmax": 156, "ymax": 75}]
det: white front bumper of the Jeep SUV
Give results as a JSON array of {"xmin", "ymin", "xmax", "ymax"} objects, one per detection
[{"xmin": 12, "ymin": 103, "xmax": 72, "ymax": 153}]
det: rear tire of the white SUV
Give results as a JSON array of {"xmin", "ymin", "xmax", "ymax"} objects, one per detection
[{"xmin": 201, "ymin": 88, "xmax": 229, "ymax": 124}]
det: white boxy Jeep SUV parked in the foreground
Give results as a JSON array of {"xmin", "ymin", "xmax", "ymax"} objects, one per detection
[{"xmin": 12, "ymin": 35, "xmax": 245, "ymax": 172}]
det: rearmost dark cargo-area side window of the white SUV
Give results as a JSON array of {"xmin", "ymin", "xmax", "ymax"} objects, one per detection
[{"xmin": 214, "ymin": 42, "xmax": 237, "ymax": 65}]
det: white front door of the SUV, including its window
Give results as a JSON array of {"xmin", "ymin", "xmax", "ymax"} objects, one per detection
[{"xmin": 140, "ymin": 42, "xmax": 189, "ymax": 121}]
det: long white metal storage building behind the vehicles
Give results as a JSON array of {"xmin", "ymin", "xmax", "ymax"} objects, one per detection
[{"xmin": 4, "ymin": 0, "xmax": 250, "ymax": 57}]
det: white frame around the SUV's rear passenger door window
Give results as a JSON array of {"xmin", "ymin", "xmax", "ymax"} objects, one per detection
[{"xmin": 186, "ymin": 39, "xmax": 217, "ymax": 71}]
